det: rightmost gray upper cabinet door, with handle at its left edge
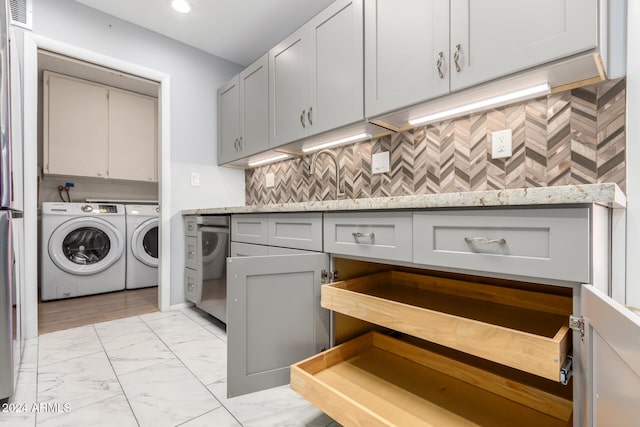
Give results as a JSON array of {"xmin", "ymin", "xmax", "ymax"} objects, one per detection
[{"xmin": 450, "ymin": 0, "xmax": 598, "ymax": 90}]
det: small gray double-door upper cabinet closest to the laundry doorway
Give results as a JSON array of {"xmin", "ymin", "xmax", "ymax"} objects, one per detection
[{"xmin": 218, "ymin": 54, "xmax": 269, "ymax": 164}]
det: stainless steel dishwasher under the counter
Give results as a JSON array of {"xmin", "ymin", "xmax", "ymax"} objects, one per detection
[{"xmin": 185, "ymin": 216, "xmax": 230, "ymax": 323}]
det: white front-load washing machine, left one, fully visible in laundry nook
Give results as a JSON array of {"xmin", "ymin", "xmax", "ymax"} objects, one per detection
[{"xmin": 40, "ymin": 203, "xmax": 127, "ymax": 301}]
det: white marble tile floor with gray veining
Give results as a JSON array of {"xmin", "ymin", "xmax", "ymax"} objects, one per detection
[{"xmin": 0, "ymin": 308, "xmax": 339, "ymax": 427}]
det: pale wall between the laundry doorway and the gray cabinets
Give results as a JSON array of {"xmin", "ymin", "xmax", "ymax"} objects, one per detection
[{"xmin": 33, "ymin": 0, "xmax": 244, "ymax": 305}]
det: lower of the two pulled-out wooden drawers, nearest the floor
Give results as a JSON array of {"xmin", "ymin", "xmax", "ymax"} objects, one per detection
[{"xmin": 291, "ymin": 332, "xmax": 572, "ymax": 427}]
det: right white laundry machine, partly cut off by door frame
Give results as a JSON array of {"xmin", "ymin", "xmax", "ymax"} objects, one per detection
[{"xmin": 125, "ymin": 205, "xmax": 160, "ymax": 289}]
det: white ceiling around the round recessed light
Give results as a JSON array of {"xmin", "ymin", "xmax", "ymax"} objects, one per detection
[{"xmin": 75, "ymin": 0, "xmax": 333, "ymax": 66}]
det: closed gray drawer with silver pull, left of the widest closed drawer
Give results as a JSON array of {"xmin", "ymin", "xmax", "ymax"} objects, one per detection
[{"xmin": 324, "ymin": 212, "xmax": 412, "ymax": 261}]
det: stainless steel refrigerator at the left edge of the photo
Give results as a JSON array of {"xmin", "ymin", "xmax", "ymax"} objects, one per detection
[{"xmin": 0, "ymin": 0, "xmax": 22, "ymax": 400}]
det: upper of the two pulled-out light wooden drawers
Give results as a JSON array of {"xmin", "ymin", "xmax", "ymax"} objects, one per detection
[{"xmin": 321, "ymin": 271, "xmax": 572, "ymax": 381}]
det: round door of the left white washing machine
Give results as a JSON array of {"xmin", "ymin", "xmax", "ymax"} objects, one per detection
[{"xmin": 49, "ymin": 217, "xmax": 125, "ymax": 276}]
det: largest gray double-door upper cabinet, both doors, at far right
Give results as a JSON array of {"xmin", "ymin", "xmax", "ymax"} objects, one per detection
[{"xmin": 364, "ymin": 0, "xmax": 598, "ymax": 118}]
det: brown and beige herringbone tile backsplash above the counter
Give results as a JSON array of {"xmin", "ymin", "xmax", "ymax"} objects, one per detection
[{"xmin": 245, "ymin": 79, "xmax": 626, "ymax": 205}]
